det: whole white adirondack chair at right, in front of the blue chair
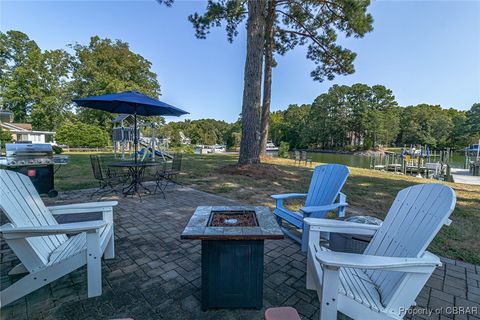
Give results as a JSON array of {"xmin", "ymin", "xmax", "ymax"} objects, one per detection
[{"xmin": 305, "ymin": 184, "xmax": 456, "ymax": 320}]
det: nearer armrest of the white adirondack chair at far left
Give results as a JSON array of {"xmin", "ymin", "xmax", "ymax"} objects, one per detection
[{"xmin": 0, "ymin": 220, "xmax": 107, "ymax": 240}]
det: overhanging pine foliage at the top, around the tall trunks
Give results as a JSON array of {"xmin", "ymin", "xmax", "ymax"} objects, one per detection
[{"xmin": 189, "ymin": 0, "xmax": 373, "ymax": 81}]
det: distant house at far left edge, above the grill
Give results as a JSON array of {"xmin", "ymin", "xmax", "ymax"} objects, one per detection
[{"xmin": 0, "ymin": 110, "xmax": 55, "ymax": 144}]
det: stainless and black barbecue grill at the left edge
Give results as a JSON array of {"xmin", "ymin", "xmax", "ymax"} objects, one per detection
[{"xmin": 0, "ymin": 143, "xmax": 68, "ymax": 197}]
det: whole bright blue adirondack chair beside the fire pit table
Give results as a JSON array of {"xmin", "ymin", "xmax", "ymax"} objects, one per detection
[{"xmin": 271, "ymin": 164, "xmax": 350, "ymax": 251}]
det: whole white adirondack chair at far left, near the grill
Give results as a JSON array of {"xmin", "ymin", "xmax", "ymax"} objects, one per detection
[{"xmin": 0, "ymin": 170, "xmax": 117, "ymax": 307}]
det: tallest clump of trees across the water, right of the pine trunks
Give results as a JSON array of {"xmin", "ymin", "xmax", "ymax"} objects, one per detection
[{"xmin": 309, "ymin": 83, "xmax": 399, "ymax": 149}]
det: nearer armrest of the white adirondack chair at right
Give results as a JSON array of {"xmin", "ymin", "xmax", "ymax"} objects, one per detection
[{"xmin": 315, "ymin": 251, "xmax": 442, "ymax": 273}]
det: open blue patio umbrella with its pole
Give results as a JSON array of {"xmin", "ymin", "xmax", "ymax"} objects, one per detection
[{"xmin": 72, "ymin": 91, "xmax": 188, "ymax": 162}]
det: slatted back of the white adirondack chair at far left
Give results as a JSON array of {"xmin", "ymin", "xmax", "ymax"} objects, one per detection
[{"xmin": 0, "ymin": 170, "xmax": 67, "ymax": 270}]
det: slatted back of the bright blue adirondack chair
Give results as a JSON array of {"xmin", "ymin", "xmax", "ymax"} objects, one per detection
[{"xmin": 305, "ymin": 164, "xmax": 350, "ymax": 207}]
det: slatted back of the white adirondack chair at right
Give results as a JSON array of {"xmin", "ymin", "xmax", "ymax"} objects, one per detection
[{"xmin": 365, "ymin": 183, "xmax": 456, "ymax": 306}]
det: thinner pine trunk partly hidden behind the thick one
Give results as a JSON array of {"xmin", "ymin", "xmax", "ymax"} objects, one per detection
[{"xmin": 260, "ymin": 0, "xmax": 275, "ymax": 156}]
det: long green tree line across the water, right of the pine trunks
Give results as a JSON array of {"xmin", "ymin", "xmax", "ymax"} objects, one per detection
[{"xmin": 270, "ymin": 83, "xmax": 480, "ymax": 150}]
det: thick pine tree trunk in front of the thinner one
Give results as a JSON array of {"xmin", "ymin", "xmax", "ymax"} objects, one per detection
[{"xmin": 238, "ymin": 0, "xmax": 265, "ymax": 164}]
